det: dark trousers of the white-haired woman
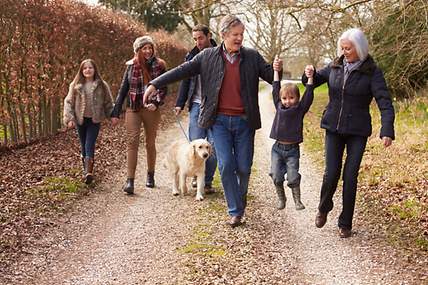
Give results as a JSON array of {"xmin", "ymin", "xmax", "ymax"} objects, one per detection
[{"xmin": 318, "ymin": 131, "xmax": 367, "ymax": 229}]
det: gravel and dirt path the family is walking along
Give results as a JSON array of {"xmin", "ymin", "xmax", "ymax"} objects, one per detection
[{"xmin": 5, "ymin": 85, "xmax": 424, "ymax": 285}]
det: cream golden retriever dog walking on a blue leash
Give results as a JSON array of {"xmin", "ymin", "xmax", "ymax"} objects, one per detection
[{"xmin": 167, "ymin": 139, "xmax": 212, "ymax": 201}]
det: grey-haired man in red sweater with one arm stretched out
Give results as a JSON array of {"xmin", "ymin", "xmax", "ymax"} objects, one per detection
[{"xmin": 144, "ymin": 15, "xmax": 282, "ymax": 227}]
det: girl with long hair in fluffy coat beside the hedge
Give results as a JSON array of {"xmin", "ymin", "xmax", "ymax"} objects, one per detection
[{"xmin": 64, "ymin": 59, "xmax": 113, "ymax": 184}]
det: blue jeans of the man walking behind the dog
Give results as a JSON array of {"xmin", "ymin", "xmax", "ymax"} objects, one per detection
[{"xmin": 189, "ymin": 103, "xmax": 217, "ymax": 186}]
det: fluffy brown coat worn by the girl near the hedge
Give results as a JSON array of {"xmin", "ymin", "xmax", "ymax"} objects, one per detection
[{"xmin": 63, "ymin": 80, "xmax": 113, "ymax": 125}]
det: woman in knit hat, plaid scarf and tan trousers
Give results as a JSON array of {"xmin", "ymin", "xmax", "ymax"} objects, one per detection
[{"xmin": 111, "ymin": 36, "xmax": 167, "ymax": 194}]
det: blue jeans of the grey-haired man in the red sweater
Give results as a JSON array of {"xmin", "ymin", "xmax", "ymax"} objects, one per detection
[{"xmin": 211, "ymin": 114, "xmax": 255, "ymax": 216}]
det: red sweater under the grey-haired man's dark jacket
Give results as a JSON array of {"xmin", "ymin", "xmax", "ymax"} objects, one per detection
[{"xmin": 217, "ymin": 54, "xmax": 245, "ymax": 116}]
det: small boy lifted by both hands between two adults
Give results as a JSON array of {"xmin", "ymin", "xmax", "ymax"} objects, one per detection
[{"xmin": 270, "ymin": 62, "xmax": 314, "ymax": 210}]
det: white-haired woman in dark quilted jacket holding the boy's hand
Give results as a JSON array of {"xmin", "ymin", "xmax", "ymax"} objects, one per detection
[{"xmin": 302, "ymin": 28, "xmax": 394, "ymax": 238}]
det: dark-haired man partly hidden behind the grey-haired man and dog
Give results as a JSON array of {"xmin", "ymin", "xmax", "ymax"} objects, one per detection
[{"xmin": 175, "ymin": 25, "xmax": 217, "ymax": 194}]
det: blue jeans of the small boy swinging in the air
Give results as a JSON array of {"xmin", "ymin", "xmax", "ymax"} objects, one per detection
[{"xmin": 270, "ymin": 142, "xmax": 301, "ymax": 188}]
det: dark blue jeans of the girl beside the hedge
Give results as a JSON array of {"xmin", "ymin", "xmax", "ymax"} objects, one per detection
[{"xmin": 76, "ymin": 118, "xmax": 100, "ymax": 158}]
